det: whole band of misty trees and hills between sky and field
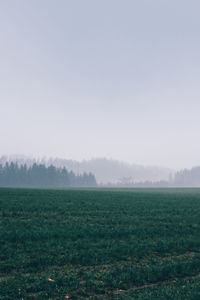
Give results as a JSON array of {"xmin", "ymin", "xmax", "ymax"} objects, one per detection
[{"xmin": 0, "ymin": 155, "xmax": 200, "ymax": 187}]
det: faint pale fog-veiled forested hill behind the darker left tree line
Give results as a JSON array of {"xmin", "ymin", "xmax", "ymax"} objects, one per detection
[{"xmin": 0, "ymin": 156, "xmax": 173, "ymax": 184}]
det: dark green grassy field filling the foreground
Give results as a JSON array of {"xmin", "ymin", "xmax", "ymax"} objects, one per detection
[{"xmin": 0, "ymin": 188, "xmax": 200, "ymax": 300}]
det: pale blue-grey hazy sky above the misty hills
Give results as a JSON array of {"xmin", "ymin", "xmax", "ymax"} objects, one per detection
[{"xmin": 0, "ymin": 0, "xmax": 200, "ymax": 168}]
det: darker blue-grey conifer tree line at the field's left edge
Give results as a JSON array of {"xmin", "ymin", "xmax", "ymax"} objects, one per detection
[{"xmin": 0, "ymin": 162, "xmax": 97, "ymax": 187}]
